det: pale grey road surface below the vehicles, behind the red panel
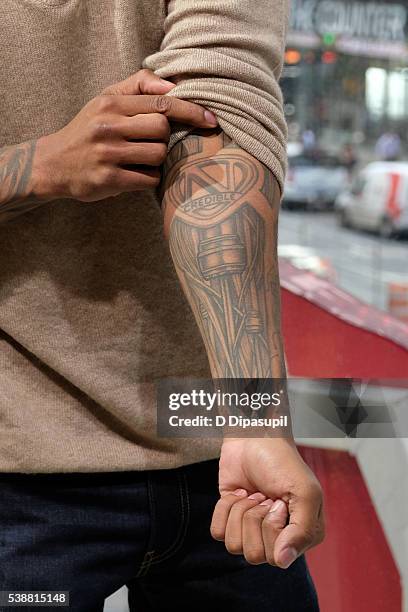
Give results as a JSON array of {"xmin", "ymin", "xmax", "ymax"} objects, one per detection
[{"xmin": 279, "ymin": 210, "xmax": 408, "ymax": 310}]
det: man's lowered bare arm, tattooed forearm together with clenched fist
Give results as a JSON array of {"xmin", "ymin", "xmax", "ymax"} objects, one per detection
[{"xmin": 163, "ymin": 131, "xmax": 324, "ymax": 568}]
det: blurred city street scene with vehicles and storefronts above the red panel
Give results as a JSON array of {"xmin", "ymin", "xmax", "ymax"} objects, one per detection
[{"xmin": 280, "ymin": 0, "xmax": 408, "ymax": 320}]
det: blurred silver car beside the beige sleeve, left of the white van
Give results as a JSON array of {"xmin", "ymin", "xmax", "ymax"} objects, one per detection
[{"xmin": 283, "ymin": 151, "xmax": 349, "ymax": 210}]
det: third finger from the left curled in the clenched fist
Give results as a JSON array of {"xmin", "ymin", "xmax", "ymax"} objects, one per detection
[{"xmin": 242, "ymin": 499, "xmax": 274, "ymax": 565}]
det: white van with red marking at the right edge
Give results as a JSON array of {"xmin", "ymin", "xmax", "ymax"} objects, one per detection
[{"xmin": 335, "ymin": 162, "xmax": 408, "ymax": 238}]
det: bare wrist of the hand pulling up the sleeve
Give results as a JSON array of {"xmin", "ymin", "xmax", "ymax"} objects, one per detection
[{"xmin": 32, "ymin": 134, "xmax": 68, "ymax": 202}]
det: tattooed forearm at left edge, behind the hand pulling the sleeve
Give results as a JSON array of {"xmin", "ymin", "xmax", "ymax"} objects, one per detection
[{"xmin": 0, "ymin": 141, "xmax": 42, "ymax": 223}]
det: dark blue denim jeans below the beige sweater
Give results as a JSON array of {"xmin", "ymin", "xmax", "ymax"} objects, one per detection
[{"xmin": 0, "ymin": 460, "xmax": 319, "ymax": 612}]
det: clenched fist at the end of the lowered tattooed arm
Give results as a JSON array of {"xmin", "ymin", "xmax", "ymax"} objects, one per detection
[{"xmin": 211, "ymin": 438, "xmax": 324, "ymax": 568}]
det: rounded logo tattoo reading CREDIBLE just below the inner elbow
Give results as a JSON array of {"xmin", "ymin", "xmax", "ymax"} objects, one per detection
[{"xmin": 170, "ymin": 153, "xmax": 259, "ymax": 221}]
